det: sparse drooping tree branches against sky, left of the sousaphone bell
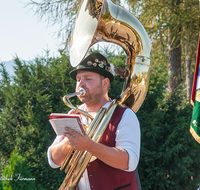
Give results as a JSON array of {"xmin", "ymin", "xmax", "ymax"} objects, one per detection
[{"xmin": 27, "ymin": 0, "xmax": 120, "ymax": 50}]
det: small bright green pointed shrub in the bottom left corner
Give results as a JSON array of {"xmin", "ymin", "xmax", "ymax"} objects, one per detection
[{"xmin": 2, "ymin": 149, "xmax": 36, "ymax": 190}]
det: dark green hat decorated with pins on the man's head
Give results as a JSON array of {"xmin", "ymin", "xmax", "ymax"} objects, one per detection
[{"xmin": 69, "ymin": 53, "xmax": 114, "ymax": 82}]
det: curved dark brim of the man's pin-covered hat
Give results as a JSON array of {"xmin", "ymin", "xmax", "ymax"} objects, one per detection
[{"xmin": 69, "ymin": 67, "xmax": 114, "ymax": 82}]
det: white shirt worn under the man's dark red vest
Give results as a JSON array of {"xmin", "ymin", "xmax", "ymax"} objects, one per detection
[{"xmin": 47, "ymin": 102, "xmax": 140, "ymax": 190}]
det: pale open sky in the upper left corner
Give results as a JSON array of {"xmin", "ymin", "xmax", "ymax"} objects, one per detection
[{"xmin": 0, "ymin": 0, "xmax": 63, "ymax": 62}]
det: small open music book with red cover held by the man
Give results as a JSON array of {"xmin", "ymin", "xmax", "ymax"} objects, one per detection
[{"xmin": 49, "ymin": 113, "xmax": 85, "ymax": 135}]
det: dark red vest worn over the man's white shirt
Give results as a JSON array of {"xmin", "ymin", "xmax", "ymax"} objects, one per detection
[{"xmin": 87, "ymin": 107, "xmax": 138, "ymax": 190}]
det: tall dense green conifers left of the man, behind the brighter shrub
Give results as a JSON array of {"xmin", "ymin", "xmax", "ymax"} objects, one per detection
[{"xmin": 0, "ymin": 51, "xmax": 72, "ymax": 189}]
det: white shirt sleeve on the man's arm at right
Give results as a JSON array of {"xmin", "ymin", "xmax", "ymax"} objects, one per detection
[{"xmin": 116, "ymin": 108, "xmax": 140, "ymax": 171}]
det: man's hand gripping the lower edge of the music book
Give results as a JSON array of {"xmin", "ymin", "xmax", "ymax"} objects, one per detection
[{"xmin": 65, "ymin": 127, "xmax": 93, "ymax": 151}]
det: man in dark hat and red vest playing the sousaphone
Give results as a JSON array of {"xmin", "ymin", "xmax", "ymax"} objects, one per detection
[{"xmin": 48, "ymin": 53, "xmax": 140, "ymax": 190}]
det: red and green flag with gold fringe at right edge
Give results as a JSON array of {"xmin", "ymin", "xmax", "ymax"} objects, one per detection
[{"xmin": 190, "ymin": 35, "xmax": 200, "ymax": 143}]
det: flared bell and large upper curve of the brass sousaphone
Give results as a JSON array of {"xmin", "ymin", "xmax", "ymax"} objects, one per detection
[{"xmin": 70, "ymin": 0, "xmax": 151, "ymax": 112}]
